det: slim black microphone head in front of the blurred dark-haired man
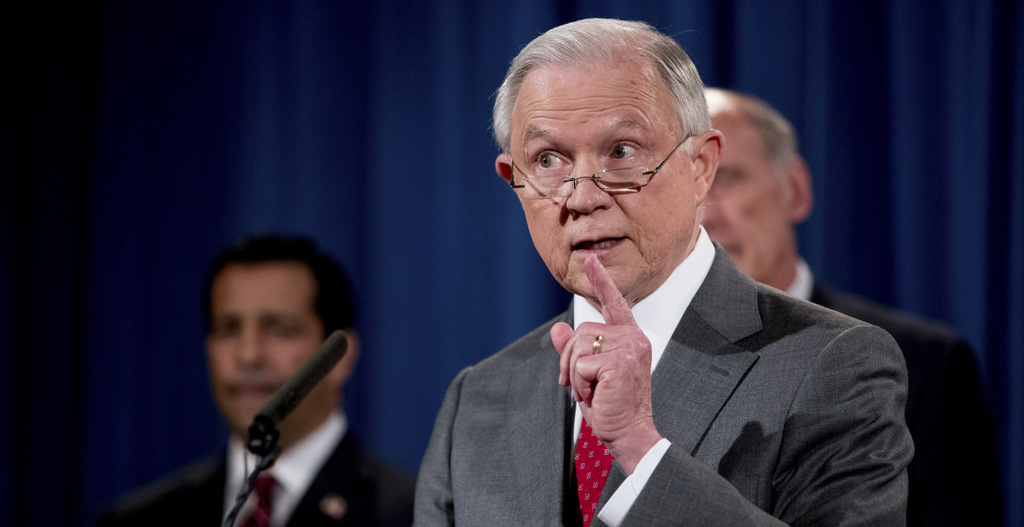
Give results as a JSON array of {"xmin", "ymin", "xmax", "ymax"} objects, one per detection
[{"xmin": 247, "ymin": 330, "xmax": 348, "ymax": 456}]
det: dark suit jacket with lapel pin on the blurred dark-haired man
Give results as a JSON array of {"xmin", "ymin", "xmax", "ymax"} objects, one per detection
[{"xmin": 96, "ymin": 434, "xmax": 415, "ymax": 527}]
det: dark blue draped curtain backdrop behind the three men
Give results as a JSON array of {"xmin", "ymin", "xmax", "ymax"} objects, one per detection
[{"xmin": 0, "ymin": 0, "xmax": 1024, "ymax": 527}]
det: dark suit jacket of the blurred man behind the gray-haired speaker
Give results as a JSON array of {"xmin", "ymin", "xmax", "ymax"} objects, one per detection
[{"xmin": 811, "ymin": 282, "xmax": 1002, "ymax": 527}]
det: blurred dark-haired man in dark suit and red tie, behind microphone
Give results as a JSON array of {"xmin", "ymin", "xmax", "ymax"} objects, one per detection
[{"xmin": 99, "ymin": 236, "xmax": 415, "ymax": 527}]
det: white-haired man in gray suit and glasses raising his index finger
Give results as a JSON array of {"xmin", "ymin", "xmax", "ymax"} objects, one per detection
[{"xmin": 415, "ymin": 19, "xmax": 913, "ymax": 526}]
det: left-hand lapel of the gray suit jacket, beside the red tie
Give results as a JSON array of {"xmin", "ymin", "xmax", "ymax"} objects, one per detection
[{"xmin": 508, "ymin": 313, "xmax": 572, "ymax": 521}]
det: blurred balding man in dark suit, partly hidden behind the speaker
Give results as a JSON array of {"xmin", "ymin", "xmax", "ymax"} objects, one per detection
[{"xmin": 703, "ymin": 88, "xmax": 1001, "ymax": 527}]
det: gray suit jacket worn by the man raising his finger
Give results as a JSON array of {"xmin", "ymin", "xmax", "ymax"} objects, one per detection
[{"xmin": 415, "ymin": 248, "xmax": 913, "ymax": 526}]
